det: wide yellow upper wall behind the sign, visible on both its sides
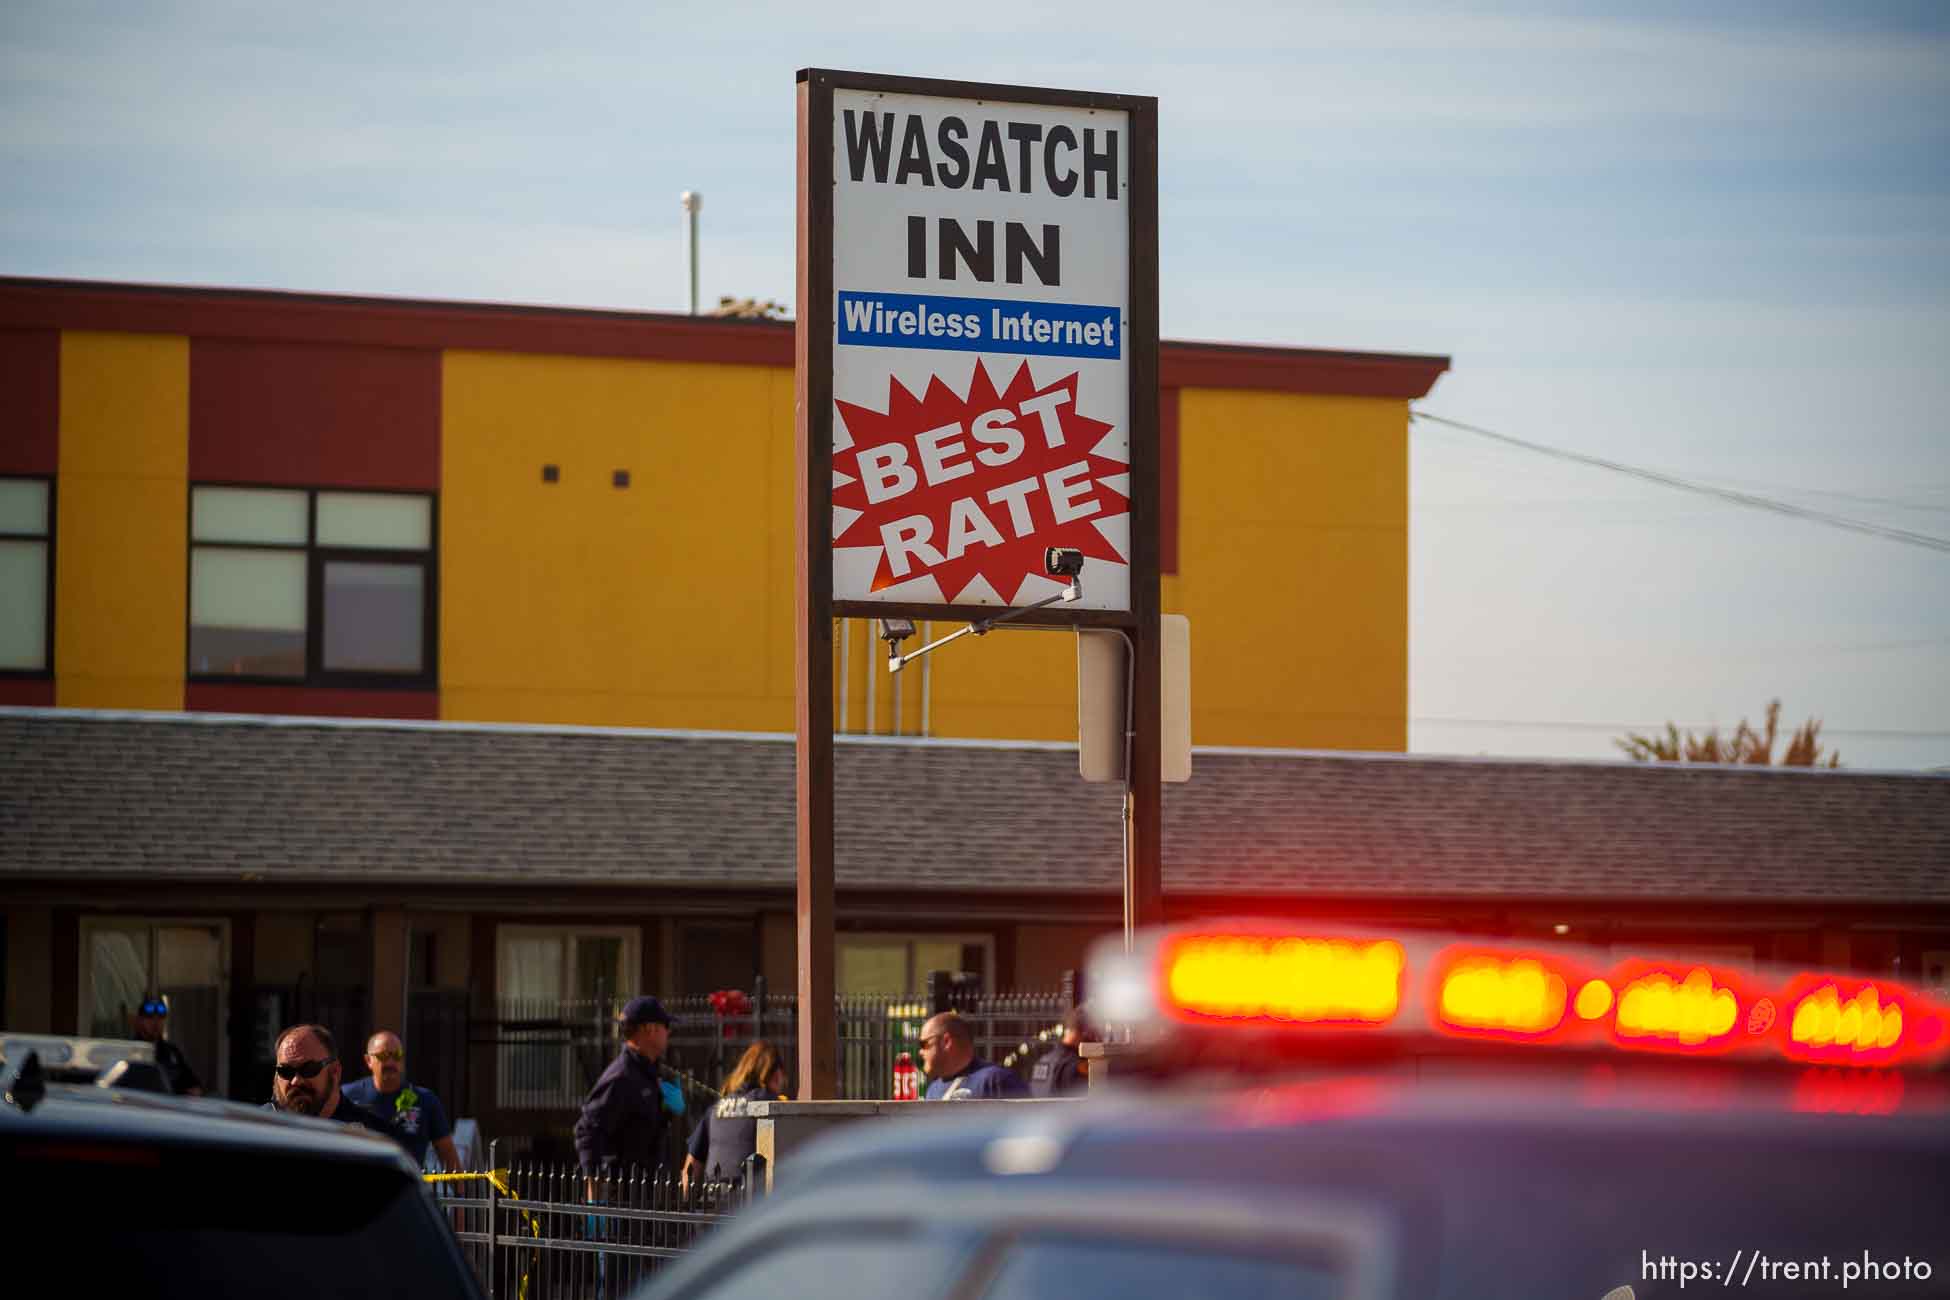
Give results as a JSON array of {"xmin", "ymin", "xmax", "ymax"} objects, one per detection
[{"xmin": 441, "ymin": 353, "xmax": 1408, "ymax": 750}]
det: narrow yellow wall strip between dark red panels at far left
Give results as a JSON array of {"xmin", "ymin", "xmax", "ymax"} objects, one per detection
[{"xmin": 55, "ymin": 331, "xmax": 189, "ymax": 709}]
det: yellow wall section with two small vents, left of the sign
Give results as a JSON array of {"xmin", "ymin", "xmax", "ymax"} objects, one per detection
[{"xmin": 441, "ymin": 351, "xmax": 796, "ymax": 731}]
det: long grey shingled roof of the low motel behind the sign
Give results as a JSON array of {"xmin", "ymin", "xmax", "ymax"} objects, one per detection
[{"xmin": 0, "ymin": 707, "xmax": 1950, "ymax": 904}]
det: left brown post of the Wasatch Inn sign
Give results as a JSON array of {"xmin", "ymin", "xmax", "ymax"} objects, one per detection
[{"xmin": 794, "ymin": 78, "xmax": 839, "ymax": 1101}]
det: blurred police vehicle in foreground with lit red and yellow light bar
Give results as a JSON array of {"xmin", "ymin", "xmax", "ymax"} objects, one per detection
[{"xmin": 642, "ymin": 926, "xmax": 1950, "ymax": 1300}]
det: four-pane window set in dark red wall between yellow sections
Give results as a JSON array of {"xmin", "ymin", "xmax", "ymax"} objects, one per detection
[{"xmin": 189, "ymin": 485, "xmax": 437, "ymax": 688}]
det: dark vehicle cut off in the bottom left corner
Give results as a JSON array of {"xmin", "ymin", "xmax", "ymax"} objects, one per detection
[{"xmin": 0, "ymin": 1051, "xmax": 480, "ymax": 1300}]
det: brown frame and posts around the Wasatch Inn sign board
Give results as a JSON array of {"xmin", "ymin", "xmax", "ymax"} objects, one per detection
[{"xmin": 794, "ymin": 68, "xmax": 1162, "ymax": 1099}]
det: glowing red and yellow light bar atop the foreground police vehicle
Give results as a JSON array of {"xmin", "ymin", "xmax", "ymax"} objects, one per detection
[{"xmin": 1090, "ymin": 922, "xmax": 1950, "ymax": 1068}]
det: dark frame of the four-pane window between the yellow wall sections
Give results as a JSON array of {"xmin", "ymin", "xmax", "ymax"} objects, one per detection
[{"xmin": 183, "ymin": 479, "xmax": 441, "ymax": 690}]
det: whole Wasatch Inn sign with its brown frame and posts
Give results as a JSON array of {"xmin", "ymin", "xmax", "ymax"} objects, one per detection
[{"xmin": 796, "ymin": 68, "xmax": 1162, "ymax": 1097}]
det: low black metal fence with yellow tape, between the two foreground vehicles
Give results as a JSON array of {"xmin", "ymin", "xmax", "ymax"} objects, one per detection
[{"xmin": 429, "ymin": 1142, "xmax": 764, "ymax": 1300}]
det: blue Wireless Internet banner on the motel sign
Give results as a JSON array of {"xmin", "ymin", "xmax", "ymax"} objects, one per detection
[{"xmin": 839, "ymin": 288, "xmax": 1123, "ymax": 361}]
